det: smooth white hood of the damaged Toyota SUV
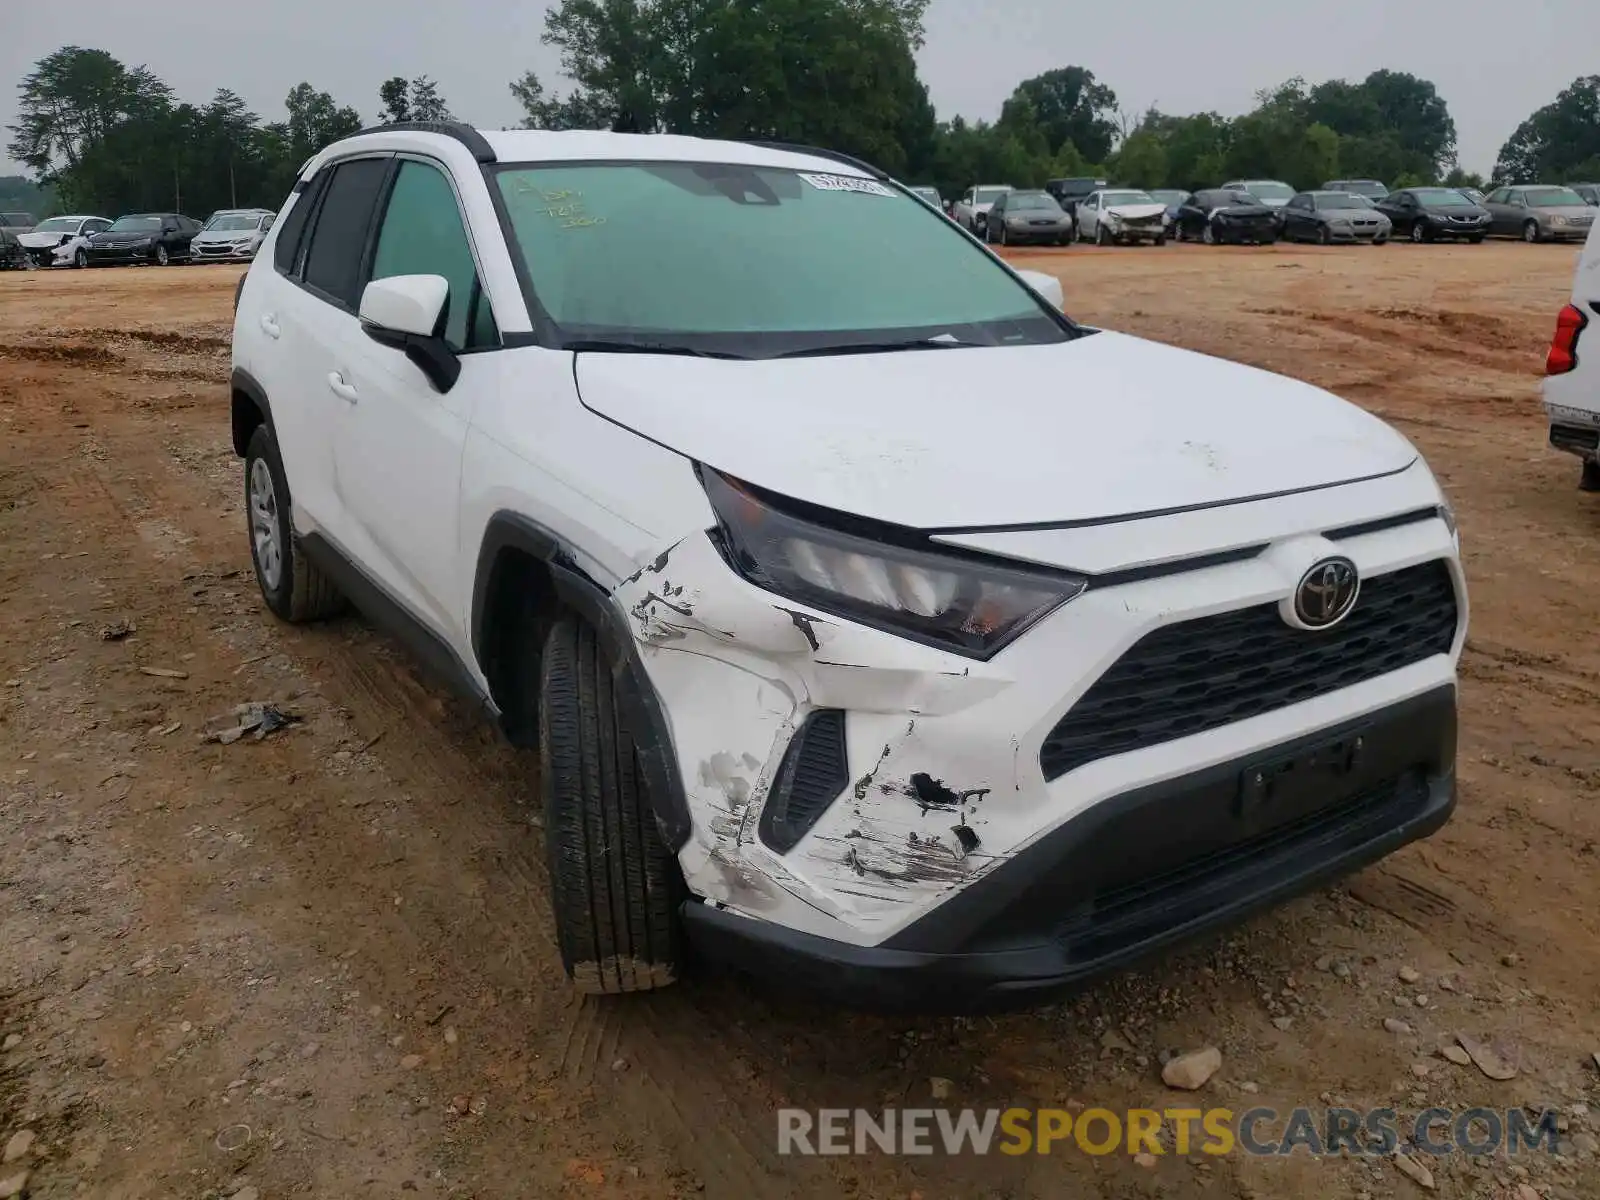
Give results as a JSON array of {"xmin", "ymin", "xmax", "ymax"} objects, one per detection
[{"xmin": 576, "ymin": 333, "xmax": 1416, "ymax": 528}]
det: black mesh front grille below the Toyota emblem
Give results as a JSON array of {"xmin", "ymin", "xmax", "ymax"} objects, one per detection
[{"xmin": 1038, "ymin": 560, "xmax": 1456, "ymax": 779}]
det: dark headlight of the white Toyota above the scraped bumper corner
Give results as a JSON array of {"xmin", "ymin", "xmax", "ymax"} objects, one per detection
[{"xmin": 701, "ymin": 467, "xmax": 1088, "ymax": 659}]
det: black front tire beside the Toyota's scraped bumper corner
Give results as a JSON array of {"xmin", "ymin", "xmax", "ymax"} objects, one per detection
[{"xmin": 539, "ymin": 618, "xmax": 683, "ymax": 995}]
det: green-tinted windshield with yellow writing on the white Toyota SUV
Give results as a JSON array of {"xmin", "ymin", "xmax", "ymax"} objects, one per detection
[{"xmin": 494, "ymin": 162, "xmax": 1072, "ymax": 357}]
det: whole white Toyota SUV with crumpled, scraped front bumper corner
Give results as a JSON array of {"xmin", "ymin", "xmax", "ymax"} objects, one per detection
[{"xmin": 232, "ymin": 125, "xmax": 1467, "ymax": 1008}]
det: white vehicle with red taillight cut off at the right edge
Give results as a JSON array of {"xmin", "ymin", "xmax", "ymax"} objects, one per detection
[{"xmin": 1544, "ymin": 222, "xmax": 1600, "ymax": 491}]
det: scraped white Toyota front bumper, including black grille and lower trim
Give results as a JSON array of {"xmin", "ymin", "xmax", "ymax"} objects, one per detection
[{"xmin": 616, "ymin": 464, "xmax": 1467, "ymax": 1005}]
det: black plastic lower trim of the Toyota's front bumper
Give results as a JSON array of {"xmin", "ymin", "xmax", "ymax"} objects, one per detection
[{"xmin": 683, "ymin": 686, "xmax": 1456, "ymax": 1011}]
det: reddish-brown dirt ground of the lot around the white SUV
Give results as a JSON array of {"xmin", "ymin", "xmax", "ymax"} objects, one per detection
[{"xmin": 0, "ymin": 243, "xmax": 1600, "ymax": 1200}]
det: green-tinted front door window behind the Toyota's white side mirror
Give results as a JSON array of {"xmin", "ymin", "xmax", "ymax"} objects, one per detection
[{"xmin": 373, "ymin": 158, "xmax": 499, "ymax": 350}]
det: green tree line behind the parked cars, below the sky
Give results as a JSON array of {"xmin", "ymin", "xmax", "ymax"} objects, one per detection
[{"xmin": 10, "ymin": 0, "xmax": 1600, "ymax": 214}]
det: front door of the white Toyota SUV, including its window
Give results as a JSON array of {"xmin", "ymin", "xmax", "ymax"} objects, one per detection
[{"xmin": 331, "ymin": 155, "xmax": 499, "ymax": 650}]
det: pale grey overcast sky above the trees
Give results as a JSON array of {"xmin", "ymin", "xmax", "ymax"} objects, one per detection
[{"xmin": 0, "ymin": 0, "xmax": 1600, "ymax": 173}]
